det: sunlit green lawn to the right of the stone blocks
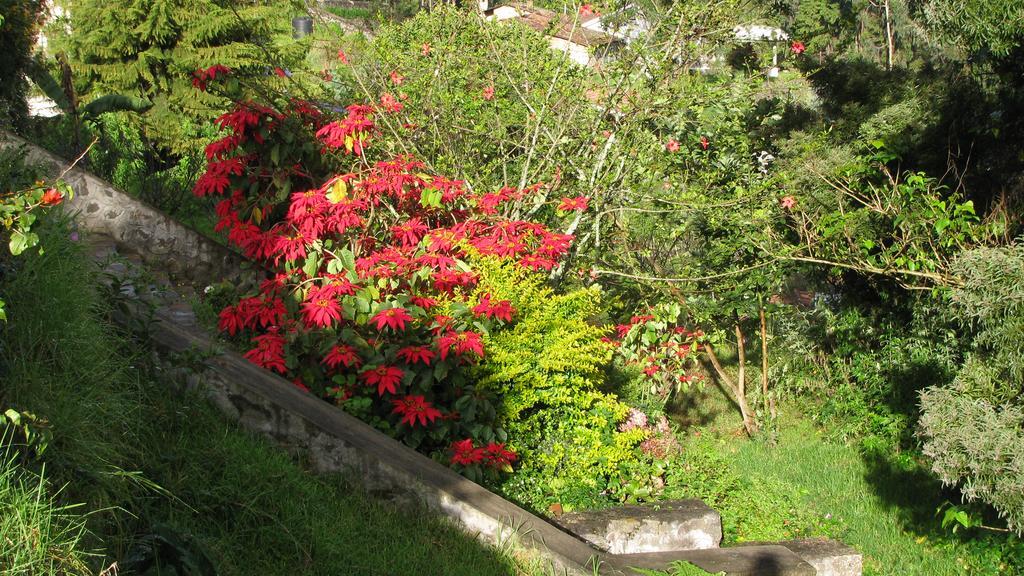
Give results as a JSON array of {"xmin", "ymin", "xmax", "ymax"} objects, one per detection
[{"xmin": 681, "ymin": 373, "xmax": 1021, "ymax": 576}]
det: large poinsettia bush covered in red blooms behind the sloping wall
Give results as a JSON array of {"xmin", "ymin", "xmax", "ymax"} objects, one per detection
[{"xmin": 195, "ymin": 69, "xmax": 579, "ymax": 467}]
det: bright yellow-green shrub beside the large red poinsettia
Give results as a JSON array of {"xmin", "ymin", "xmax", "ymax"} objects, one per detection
[{"xmin": 466, "ymin": 259, "xmax": 646, "ymax": 510}]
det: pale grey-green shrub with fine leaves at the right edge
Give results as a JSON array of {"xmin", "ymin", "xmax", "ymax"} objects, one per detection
[{"xmin": 921, "ymin": 243, "xmax": 1024, "ymax": 533}]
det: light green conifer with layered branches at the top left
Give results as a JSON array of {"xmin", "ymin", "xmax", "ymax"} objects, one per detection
[{"xmin": 54, "ymin": 0, "xmax": 304, "ymax": 156}]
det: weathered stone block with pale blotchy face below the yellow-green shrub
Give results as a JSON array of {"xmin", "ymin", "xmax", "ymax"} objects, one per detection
[{"xmin": 555, "ymin": 500, "xmax": 722, "ymax": 554}]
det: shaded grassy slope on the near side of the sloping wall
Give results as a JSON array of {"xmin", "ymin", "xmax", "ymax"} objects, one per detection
[{"xmin": 0, "ymin": 216, "xmax": 541, "ymax": 576}]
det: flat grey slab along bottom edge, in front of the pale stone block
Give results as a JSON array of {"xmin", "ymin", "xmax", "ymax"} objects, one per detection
[{"xmin": 604, "ymin": 544, "xmax": 816, "ymax": 576}]
